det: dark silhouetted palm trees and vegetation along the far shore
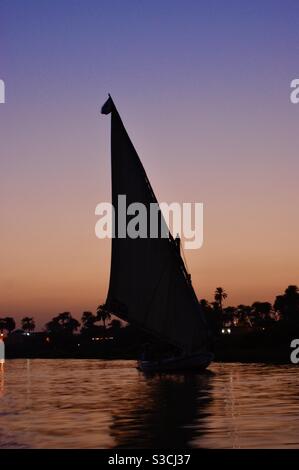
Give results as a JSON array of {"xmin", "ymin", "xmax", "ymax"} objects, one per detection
[{"xmin": 0, "ymin": 285, "xmax": 299, "ymax": 363}]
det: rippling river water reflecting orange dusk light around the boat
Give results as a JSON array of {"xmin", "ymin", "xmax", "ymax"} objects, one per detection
[{"xmin": 0, "ymin": 359, "xmax": 299, "ymax": 448}]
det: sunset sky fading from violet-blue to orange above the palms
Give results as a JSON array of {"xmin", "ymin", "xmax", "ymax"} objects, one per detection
[{"xmin": 0, "ymin": 0, "xmax": 299, "ymax": 326}]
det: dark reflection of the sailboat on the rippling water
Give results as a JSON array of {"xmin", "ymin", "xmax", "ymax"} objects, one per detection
[{"xmin": 111, "ymin": 372, "xmax": 213, "ymax": 448}]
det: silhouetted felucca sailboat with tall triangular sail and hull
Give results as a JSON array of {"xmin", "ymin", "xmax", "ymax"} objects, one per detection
[{"xmin": 102, "ymin": 95, "xmax": 213, "ymax": 371}]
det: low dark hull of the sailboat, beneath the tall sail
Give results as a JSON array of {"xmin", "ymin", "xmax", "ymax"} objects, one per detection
[{"xmin": 137, "ymin": 352, "xmax": 214, "ymax": 372}]
